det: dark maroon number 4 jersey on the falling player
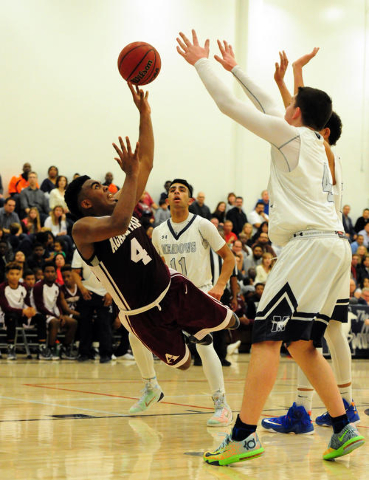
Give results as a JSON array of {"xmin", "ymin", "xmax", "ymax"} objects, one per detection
[{"xmin": 87, "ymin": 217, "xmax": 170, "ymax": 315}]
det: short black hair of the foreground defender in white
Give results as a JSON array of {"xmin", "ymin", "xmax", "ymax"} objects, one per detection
[{"xmin": 295, "ymin": 87, "xmax": 332, "ymax": 131}]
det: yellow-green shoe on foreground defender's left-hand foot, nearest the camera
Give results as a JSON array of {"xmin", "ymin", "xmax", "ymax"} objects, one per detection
[{"xmin": 203, "ymin": 432, "xmax": 264, "ymax": 466}]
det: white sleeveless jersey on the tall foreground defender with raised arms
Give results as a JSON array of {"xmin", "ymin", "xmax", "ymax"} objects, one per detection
[{"xmin": 268, "ymin": 127, "xmax": 343, "ymax": 246}]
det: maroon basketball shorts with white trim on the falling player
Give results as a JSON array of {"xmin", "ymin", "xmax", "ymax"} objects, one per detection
[{"xmin": 119, "ymin": 270, "xmax": 232, "ymax": 367}]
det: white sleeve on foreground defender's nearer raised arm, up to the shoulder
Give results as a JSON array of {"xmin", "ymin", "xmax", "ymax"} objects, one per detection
[{"xmin": 195, "ymin": 58, "xmax": 300, "ymax": 171}]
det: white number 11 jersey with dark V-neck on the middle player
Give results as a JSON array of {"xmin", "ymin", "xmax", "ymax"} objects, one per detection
[{"xmin": 152, "ymin": 213, "xmax": 225, "ymax": 290}]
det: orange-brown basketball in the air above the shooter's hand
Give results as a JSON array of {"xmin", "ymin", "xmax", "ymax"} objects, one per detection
[{"xmin": 118, "ymin": 42, "xmax": 161, "ymax": 85}]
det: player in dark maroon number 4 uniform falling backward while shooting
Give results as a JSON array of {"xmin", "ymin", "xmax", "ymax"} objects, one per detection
[{"xmin": 65, "ymin": 84, "xmax": 239, "ymax": 376}]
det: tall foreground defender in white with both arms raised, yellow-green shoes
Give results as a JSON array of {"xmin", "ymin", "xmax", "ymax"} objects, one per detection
[{"xmin": 177, "ymin": 30, "xmax": 364, "ymax": 465}]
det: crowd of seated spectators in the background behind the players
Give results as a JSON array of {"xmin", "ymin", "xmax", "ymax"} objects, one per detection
[{"xmin": 0, "ymin": 167, "xmax": 369, "ymax": 362}]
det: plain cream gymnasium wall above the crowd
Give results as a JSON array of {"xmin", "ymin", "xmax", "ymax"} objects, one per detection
[{"xmin": 0, "ymin": 0, "xmax": 369, "ymax": 218}]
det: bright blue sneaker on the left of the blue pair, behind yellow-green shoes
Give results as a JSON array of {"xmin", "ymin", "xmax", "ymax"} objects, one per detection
[{"xmin": 261, "ymin": 402, "xmax": 314, "ymax": 435}]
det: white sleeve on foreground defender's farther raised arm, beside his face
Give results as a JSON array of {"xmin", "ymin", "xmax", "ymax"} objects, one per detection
[{"xmin": 232, "ymin": 65, "xmax": 283, "ymax": 117}]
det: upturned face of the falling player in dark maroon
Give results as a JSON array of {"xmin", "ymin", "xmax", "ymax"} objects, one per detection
[{"xmin": 81, "ymin": 179, "xmax": 118, "ymax": 216}]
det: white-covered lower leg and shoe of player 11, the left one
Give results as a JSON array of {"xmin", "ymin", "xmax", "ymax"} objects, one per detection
[{"xmin": 129, "ymin": 333, "xmax": 164, "ymax": 413}]
